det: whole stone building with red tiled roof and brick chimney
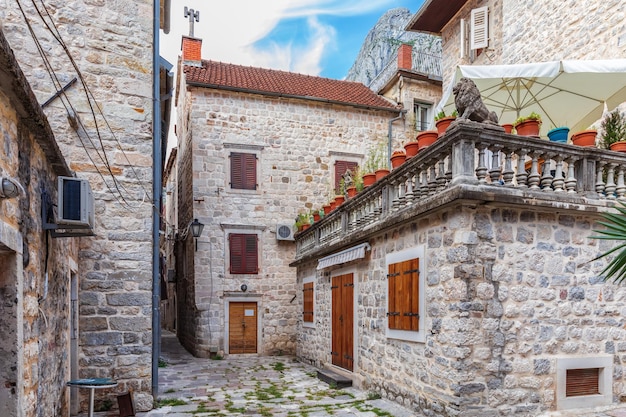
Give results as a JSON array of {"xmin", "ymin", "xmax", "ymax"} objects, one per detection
[{"xmin": 169, "ymin": 32, "xmax": 444, "ymax": 356}]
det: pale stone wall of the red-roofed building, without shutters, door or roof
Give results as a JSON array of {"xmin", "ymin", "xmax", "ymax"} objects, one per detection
[{"xmin": 177, "ymin": 83, "xmax": 404, "ymax": 356}]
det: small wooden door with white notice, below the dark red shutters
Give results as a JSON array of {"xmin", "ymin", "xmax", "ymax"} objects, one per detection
[{"xmin": 228, "ymin": 302, "xmax": 257, "ymax": 354}]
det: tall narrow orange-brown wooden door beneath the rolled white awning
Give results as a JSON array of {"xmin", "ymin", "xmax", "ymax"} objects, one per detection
[{"xmin": 331, "ymin": 274, "xmax": 354, "ymax": 371}]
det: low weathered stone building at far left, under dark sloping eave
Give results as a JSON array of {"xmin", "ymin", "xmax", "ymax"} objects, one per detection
[{"xmin": 0, "ymin": 31, "xmax": 79, "ymax": 417}]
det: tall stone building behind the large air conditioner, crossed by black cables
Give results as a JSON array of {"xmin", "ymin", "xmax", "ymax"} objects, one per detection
[{"xmin": 0, "ymin": 0, "xmax": 171, "ymax": 415}]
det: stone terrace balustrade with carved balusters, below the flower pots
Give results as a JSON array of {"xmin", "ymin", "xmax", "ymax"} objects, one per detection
[{"xmin": 292, "ymin": 122, "xmax": 626, "ymax": 266}]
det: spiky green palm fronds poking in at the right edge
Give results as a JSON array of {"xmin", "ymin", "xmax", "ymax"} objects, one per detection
[{"xmin": 591, "ymin": 201, "xmax": 626, "ymax": 284}]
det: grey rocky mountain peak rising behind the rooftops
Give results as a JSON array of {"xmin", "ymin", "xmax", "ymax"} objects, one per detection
[{"xmin": 346, "ymin": 8, "xmax": 441, "ymax": 86}]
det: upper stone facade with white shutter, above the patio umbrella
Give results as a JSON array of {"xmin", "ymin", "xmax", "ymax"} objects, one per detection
[{"xmin": 441, "ymin": 0, "xmax": 626, "ymax": 89}]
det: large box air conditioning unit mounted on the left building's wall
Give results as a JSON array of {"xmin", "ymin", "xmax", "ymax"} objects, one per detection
[{"xmin": 57, "ymin": 177, "xmax": 95, "ymax": 229}]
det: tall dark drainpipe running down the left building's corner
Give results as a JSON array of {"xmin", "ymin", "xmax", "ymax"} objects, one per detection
[{"xmin": 152, "ymin": 0, "xmax": 162, "ymax": 400}]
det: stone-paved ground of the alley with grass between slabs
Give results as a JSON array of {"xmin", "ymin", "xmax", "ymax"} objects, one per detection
[{"xmin": 83, "ymin": 331, "xmax": 626, "ymax": 417}]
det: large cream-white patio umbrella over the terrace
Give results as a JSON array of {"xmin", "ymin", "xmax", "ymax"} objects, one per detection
[{"xmin": 435, "ymin": 59, "xmax": 626, "ymax": 136}]
